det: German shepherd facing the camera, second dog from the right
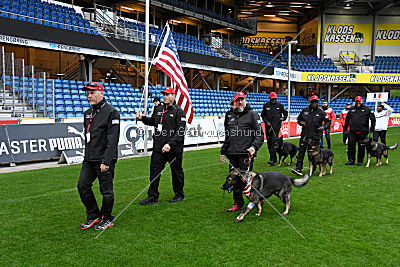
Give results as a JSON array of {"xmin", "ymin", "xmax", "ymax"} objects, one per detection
[{"xmin": 307, "ymin": 139, "xmax": 334, "ymax": 177}]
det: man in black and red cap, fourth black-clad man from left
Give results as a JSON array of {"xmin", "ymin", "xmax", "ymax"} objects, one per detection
[{"xmin": 261, "ymin": 92, "xmax": 288, "ymax": 165}]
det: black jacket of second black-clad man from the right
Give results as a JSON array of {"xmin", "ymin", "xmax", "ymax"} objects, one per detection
[{"xmin": 297, "ymin": 106, "xmax": 331, "ymax": 139}]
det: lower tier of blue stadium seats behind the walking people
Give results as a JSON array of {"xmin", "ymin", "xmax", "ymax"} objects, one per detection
[{"xmin": 5, "ymin": 76, "xmax": 400, "ymax": 120}]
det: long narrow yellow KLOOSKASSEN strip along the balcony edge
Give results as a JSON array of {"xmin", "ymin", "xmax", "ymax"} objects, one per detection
[{"xmin": 301, "ymin": 72, "xmax": 400, "ymax": 84}]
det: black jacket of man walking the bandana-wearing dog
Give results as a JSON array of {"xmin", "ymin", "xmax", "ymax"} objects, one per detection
[{"xmin": 221, "ymin": 105, "xmax": 264, "ymax": 156}]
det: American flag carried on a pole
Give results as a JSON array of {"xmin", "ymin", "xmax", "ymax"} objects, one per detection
[{"xmin": 154, "ymin": 24, "xmax": 193, "ymax": 123}]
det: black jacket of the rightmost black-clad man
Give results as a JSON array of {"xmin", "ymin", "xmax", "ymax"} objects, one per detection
[{"xmin": 344, "ymin": 104, "xmax": 376, "ymax": 133}]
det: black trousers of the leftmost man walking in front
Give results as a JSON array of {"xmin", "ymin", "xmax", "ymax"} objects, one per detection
[{"xmin": 78, "ymin": 161, "xmax": 116, "ymax": 220}]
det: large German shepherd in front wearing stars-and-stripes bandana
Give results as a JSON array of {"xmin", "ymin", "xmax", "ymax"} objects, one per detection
[{"xmin": 221, "ymin": 170, "xmax": 310, "ymax": 223}]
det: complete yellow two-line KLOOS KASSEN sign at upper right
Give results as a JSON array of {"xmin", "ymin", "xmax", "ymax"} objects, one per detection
[{"xmin": 324, "ymin": 23, "xmax": 372, "ymax": 45}]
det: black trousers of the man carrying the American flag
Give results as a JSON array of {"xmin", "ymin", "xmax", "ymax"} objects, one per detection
[{"xmin": 147, "ymin": 151, "xmax": 185, "ymax": 199}]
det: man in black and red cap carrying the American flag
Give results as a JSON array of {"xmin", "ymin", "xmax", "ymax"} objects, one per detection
[{"xmin": 136, "ymin": 87, "xmax": 186, "ymax": 205}]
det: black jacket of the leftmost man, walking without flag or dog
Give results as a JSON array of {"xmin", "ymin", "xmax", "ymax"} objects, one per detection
[{"xmin": 83, "ymin": 99, "xmax": 120, "ymax": 166}]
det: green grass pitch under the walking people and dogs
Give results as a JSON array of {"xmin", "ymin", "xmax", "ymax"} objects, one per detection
[{"xmin": 0, "ymin": 128, "xmax": 400, "ymax": 266}]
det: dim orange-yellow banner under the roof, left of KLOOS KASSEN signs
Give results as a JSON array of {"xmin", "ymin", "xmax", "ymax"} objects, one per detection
[{"xmin": 242, "ymin": 32, "xmax": 296, "ymax": 48}]
